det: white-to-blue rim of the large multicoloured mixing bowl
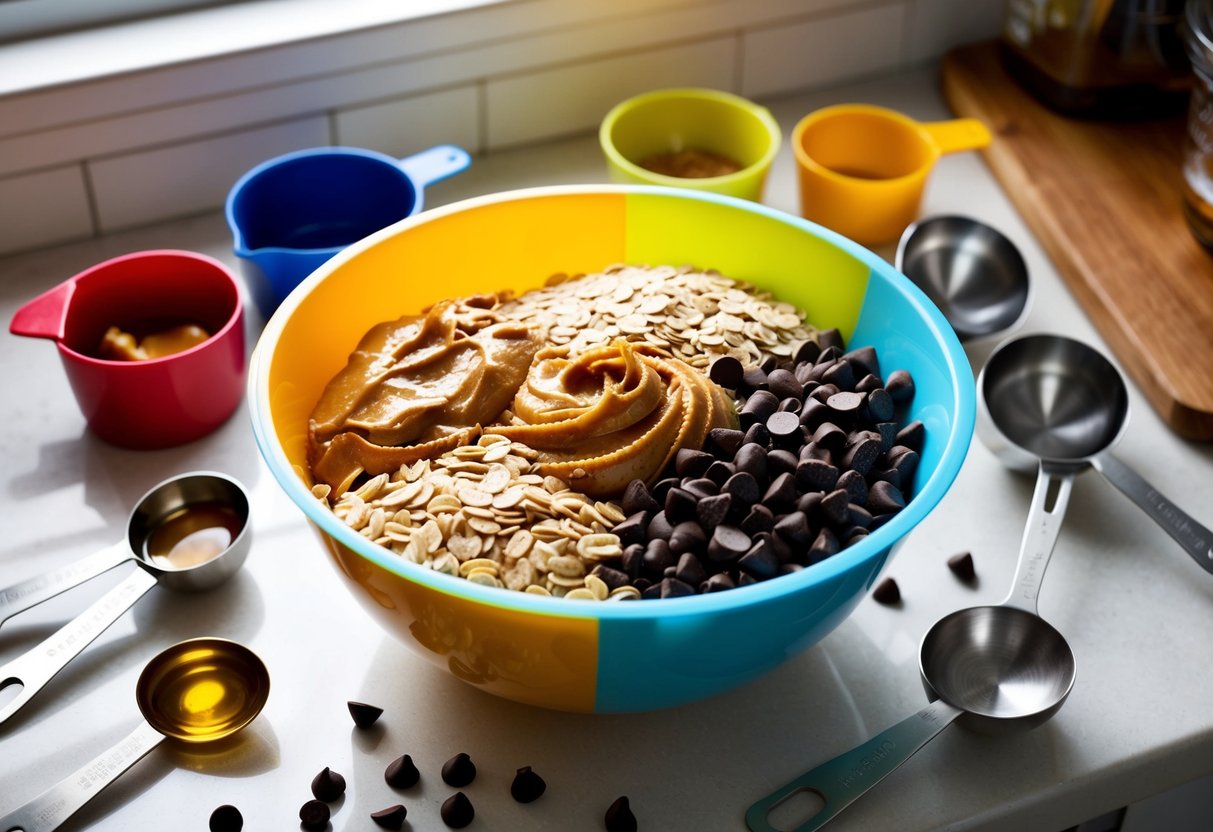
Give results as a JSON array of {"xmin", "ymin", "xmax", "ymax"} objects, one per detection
[{"xmin": 247, "ymin": 184, "xmax": 976, "ymax": 620}]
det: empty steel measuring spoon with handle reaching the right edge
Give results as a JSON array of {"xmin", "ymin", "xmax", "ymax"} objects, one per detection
[{"xmin": 978, "ymin": 335, "xmax": 1213, "ymax": 574}]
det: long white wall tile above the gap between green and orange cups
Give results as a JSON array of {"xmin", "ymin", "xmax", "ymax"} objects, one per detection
[{"xmin": 741, "ymin": 2, "xmax": 905, "ymax": 97}]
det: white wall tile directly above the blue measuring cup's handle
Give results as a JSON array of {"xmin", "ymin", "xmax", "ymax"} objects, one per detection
[{"xmin": 334, "ymin": 85, "xmax": 480, "ymax": 156}]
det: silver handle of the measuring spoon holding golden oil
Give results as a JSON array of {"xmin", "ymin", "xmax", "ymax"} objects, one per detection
[{"xmin": 0, "ymin": 723, "xmax": 164, "ymax": 832}]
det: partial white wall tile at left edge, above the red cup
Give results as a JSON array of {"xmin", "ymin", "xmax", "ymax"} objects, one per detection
[{"xmin": 0, "ymin": 165, "xmax": 93, "ymax": 252}]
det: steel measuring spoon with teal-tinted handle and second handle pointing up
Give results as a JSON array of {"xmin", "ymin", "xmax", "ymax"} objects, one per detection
[{"xmin": 746, "ymin": 458, "xmax": 1075, "ymax": 832}]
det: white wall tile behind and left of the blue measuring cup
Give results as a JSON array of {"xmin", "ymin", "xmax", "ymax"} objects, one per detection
[{"xmin": 89, "ymin": 118, "xmax": 332, "ymax": 232}]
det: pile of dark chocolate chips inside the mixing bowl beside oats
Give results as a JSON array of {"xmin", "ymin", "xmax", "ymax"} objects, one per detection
[{"xmin": 591, "ymin": 331, "xmax": 924, "ymax": 598}]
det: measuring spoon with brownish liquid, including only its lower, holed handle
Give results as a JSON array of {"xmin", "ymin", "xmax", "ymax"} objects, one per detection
[{"xmin": 0, "ymin": 472, "xmax": 252, "ymax": 724}]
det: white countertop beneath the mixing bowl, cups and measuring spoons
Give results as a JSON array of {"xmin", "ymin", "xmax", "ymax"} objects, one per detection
[{"xmin": 0, "ymin": 65, "xmax": 1213, "ymax": 832}]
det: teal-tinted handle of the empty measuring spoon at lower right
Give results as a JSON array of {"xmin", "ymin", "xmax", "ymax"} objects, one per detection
[{"xmin": 746, "ymin": 700, "xmax": 964, "ymax": 832}]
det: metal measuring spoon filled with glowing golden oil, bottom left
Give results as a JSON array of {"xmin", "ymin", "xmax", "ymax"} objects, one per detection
[{"xmin": 0, "ymin": 638, "xmax": 269, "ymax": 832}]
